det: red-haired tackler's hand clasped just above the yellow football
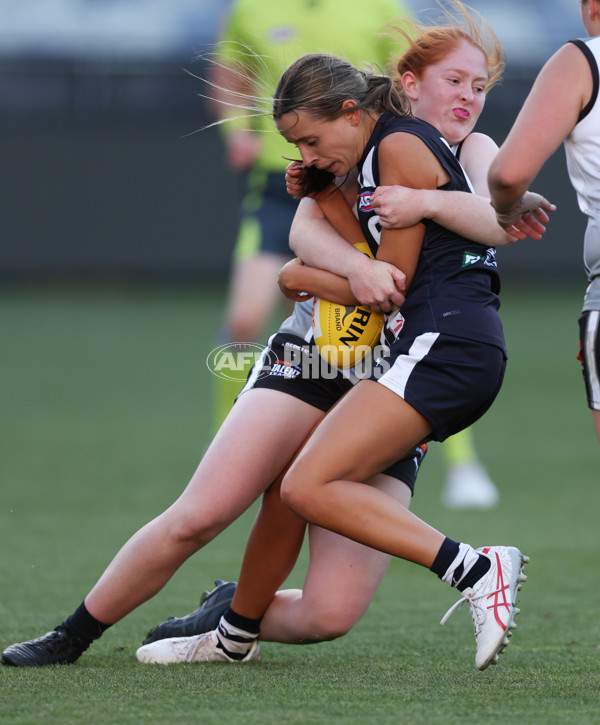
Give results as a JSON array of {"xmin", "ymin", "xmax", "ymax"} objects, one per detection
[{"xmin": 348, "ymin": 257, "xmax": 406, "ymax": 312}]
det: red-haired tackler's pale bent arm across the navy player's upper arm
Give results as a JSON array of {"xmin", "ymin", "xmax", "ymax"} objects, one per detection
[{"xmin": 373, "ymin": 133, "xmax": 553, "ymax": 247}]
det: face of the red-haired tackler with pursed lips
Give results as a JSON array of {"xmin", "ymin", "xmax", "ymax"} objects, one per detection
[{"xmin": 403, "ymin": 40, "xmax": 488, "ymax": 146}]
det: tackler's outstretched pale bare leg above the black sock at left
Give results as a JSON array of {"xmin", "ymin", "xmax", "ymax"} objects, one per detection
[{"xmin": 85, "ymin": 390, "xmax": 322, "ymax": 624}]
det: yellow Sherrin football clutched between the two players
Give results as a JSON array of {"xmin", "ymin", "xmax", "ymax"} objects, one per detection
[{"xmin": 312, "ymin": 242, "xmax": 384, "ymax": 370}]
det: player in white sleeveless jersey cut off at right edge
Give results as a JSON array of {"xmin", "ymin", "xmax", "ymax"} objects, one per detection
[{"xmin": 489, "ymin": 0, "xmax": 600, "ymax": 442}]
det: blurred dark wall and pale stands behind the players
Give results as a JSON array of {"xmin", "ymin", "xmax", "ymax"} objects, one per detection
[{"xmin": 0, "ymin": 0, "xmax": 585, "ymax": 286}]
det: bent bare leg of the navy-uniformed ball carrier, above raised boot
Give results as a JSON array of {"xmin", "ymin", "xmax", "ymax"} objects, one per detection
[{"xmin": 282, "ymin": 380, "xmax": 445, "ymax": 567}]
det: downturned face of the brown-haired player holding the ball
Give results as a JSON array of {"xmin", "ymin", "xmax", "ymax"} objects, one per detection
[{"xmin": 276, "ymin": 110, "xmax": 368, "ymax": 176}]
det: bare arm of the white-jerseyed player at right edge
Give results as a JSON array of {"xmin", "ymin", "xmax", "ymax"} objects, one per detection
[{"xmin": 488, "ymin": 43, "xmax": 592, "ymax": 226}]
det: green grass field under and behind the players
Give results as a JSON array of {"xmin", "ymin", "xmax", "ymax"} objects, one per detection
[{"xmin": 0, "ymin": 280, "xmax": 600, "ymax": 725}]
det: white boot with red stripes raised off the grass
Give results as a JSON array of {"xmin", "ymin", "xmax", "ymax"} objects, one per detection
[{"xmin": 440, "ymin": 546, "xmax": 529, "ymax": 670}]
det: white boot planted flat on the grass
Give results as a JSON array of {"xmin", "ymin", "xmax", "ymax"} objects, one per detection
[{"xmin": 135, "ymin": 630, "xmax": 260, "ymax": 665}]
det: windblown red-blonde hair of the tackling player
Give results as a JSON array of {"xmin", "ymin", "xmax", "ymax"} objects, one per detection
[{"xmin": 393, "ymin": 0, "xmax": 505, "ymax": 93}]
